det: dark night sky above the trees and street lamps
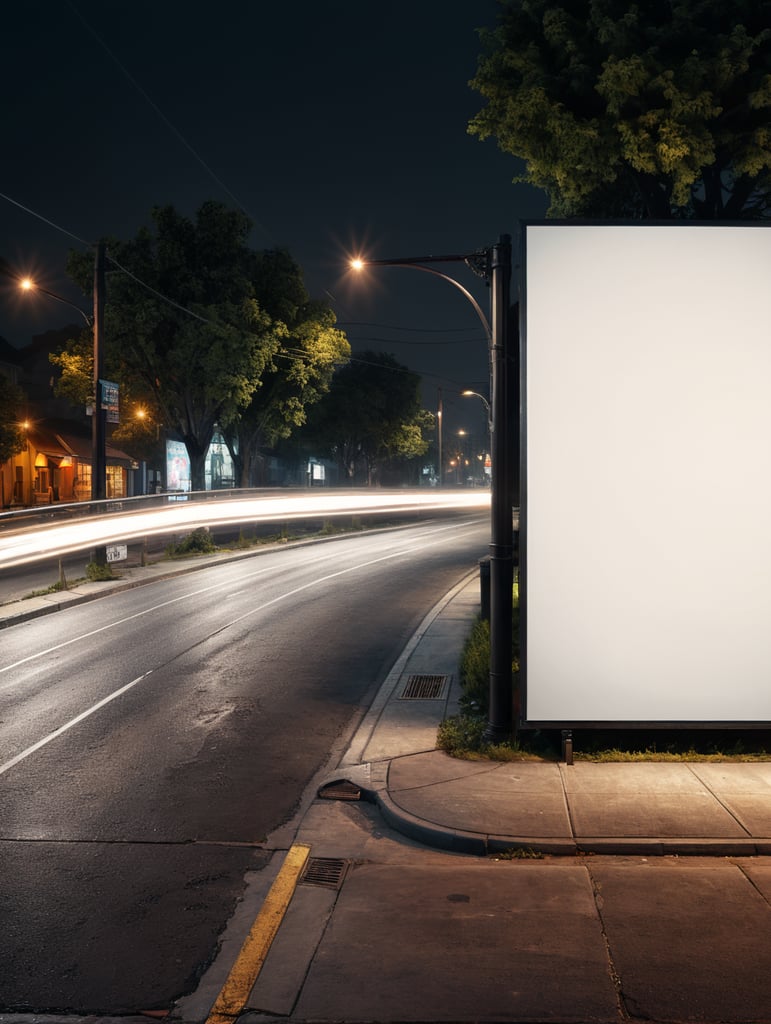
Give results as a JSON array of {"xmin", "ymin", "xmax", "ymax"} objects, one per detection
[{"xmin": 0, "ymin": 0, "xmax": 546, "ymax": 440}]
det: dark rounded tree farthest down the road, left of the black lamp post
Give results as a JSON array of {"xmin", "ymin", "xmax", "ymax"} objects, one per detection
[{"xmin": 304, "ymin": 352, "xmax": 432, "ymax": 485}]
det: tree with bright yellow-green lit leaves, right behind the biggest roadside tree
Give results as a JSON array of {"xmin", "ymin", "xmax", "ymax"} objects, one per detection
[{"xmin": 225, "ymin": 250, "xmax": 350, "ymax": 486}]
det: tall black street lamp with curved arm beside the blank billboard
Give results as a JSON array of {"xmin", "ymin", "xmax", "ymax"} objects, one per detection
[{"xmin": 350, "ymin": 234, "xmax": 514, "ymax": 741}]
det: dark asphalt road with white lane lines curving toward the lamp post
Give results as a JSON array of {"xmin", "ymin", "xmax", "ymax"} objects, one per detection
[{"xmin": 0, "ymin": 515, "xmax": 488, "ymax": 1014}]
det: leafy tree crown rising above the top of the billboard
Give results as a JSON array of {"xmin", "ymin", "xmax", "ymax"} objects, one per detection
[{"xmin": 469, "ymin": 0, "xmax": 771, "ymax": 219}]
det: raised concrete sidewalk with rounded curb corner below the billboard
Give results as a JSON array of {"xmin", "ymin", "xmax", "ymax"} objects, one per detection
[{"xmin": 319, "ymin": 575, "xmax": 771, "ymax": 856}]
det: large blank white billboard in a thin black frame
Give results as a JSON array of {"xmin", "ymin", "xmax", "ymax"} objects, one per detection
[{"xmin": 520, "ymin": 223, "xmax": 771, "ymax": 727}]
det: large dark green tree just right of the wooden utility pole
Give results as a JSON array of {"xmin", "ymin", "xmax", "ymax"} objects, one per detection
[{"xmin": 69, "ymin": 202, "xmax": 288, "ymax": 489}]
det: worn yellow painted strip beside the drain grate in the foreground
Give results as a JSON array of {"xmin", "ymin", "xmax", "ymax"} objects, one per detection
[{"xmin": 206, "ymin": 843, "xmax": 310, "ymax": 1024}]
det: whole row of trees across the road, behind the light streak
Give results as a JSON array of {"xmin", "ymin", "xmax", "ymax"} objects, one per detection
[{"xmin": 51, "ymin": 202, "xmax": 430, "ymax": 489}]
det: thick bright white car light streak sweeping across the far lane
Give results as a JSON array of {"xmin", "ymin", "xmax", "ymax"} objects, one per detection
[{"xmin": 0, "ymin": 489, "xmax": 490, "ymax": 568}]
